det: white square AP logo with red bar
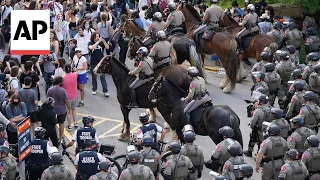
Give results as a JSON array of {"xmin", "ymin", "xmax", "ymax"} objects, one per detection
[{"xmin": 10, "ymin": 10, "xmax": 50, "ymax": 55}]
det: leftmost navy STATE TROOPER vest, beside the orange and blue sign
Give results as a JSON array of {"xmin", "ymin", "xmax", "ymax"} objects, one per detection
[{"xmin": 29, "ymin": 139, "xmax": 49, "ymax": 165}]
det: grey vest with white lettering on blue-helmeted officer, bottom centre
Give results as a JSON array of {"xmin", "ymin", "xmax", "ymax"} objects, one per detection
[{"xmin": 140, "ymin": 149, "xmax": 159, "ymax": 174}]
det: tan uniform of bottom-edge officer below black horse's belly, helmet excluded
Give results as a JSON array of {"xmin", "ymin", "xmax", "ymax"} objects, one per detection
[{"xmin": 163, "ymin": 154, "xmax": 193, "ymax": 180}]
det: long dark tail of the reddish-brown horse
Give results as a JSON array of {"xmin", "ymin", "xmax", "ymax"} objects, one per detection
[{"xmin": 226, "ymin": 40, "xmax": 238, "ymax": 90}]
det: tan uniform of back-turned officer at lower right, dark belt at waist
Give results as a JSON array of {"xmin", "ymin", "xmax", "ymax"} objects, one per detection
[{"xmin": 258, "ymin": 136, "xmax": 287, "ymax": 180}]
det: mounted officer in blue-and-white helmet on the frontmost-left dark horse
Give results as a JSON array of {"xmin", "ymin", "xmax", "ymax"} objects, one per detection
[{"xmin": 128, "ymin": 47, "xmax": 153, "ymax": 109}]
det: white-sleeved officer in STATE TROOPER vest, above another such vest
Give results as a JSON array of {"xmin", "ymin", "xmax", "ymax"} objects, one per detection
[{"xmin": 67, "ymin": 116, "xmax": 99, "ymax": 154}]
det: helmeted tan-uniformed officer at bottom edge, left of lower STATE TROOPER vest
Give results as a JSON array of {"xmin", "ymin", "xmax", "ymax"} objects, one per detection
[{"xmin": 41, "ymin": 152, "xmax": 74, "ymax": 180}]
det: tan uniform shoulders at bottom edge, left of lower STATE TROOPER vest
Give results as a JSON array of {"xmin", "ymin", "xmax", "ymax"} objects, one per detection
[{"xmin": 41, "ymin": 164, "xmax": 74, "ymax": 180}]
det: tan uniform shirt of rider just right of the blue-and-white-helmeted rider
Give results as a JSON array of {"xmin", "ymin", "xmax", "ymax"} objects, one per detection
[{"xmin": 148, "ymin": 40, "xmax": 173, "ymax": 70}]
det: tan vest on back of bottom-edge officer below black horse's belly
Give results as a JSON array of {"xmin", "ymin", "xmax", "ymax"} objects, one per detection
[{"xmin": 173, "ymin": 155, "xmax": 189, "ymax": 179}]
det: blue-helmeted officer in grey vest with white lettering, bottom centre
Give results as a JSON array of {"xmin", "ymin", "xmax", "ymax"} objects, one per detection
[{"xmin": 139, "ymin": 134, "xmax": 161, "ymax": 179}]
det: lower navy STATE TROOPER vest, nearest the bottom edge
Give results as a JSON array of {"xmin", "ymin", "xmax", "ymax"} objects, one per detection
[{"xmin": 78, "ymin": 151, "xmax": 99, "ymax": 178}]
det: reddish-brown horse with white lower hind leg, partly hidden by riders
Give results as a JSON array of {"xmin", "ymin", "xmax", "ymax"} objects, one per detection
[{"xmin": 178, "ymin": 3, "xmax": 239, "ymax": 93}]
